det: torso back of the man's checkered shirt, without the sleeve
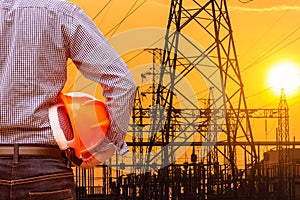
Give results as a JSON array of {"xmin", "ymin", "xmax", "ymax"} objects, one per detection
[{"xmin": 0, "ymin": 0, "xmax": 76, "ymax": 143}]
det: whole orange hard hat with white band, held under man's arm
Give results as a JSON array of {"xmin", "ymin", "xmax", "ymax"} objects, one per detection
[{"xmin": 49, "ymin": 92, "xmax": 110, "ymax": 161}]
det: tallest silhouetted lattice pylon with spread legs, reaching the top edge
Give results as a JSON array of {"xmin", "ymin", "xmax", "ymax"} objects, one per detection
[{"xmin": 155, "ymin": 0, "xmax": 257, "ymax": 196}]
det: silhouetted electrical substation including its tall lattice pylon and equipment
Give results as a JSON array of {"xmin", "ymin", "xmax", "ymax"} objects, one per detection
[{"xmin": 74, "ymin": 0, "xmax": 300, "ymax": 200}]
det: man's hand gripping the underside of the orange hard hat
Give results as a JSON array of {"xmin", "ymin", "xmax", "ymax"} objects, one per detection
[{"xmin": 79, "ymin": 145, "xmax": 115, "ymax": 169}]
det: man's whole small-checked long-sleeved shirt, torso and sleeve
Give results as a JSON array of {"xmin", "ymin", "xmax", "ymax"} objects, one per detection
[{"xmin": 0, "ymin": 0, "xmax": 136, "ymax": 153}]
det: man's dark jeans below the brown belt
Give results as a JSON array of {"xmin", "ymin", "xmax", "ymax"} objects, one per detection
[{"xmin": 0, "ymin": 157, "xmax": 76, "ymax": 200}]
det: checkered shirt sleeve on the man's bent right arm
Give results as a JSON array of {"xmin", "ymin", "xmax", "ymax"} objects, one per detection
[{"xmin": 69, "ymin": 8, "xmax": 136, "ymax": 155}]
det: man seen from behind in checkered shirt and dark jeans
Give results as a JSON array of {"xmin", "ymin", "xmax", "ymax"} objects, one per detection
[{"xmin": 0, "ymin": 0, "xmax": 135, "ymax": 200}]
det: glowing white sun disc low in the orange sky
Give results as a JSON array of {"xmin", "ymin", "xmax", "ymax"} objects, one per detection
[{"xmin": 268, "ymin": 61, "xmax": 300, "ymax": 94}]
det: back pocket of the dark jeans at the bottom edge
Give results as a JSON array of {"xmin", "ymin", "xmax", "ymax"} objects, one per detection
[{"xmin": 29, "ymin": 189, "xmax": 75, "ymax": 200}]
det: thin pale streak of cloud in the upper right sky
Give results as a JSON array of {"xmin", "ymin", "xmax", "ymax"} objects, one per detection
[{"xmin": 230, "ymin": 6, "xmax": 300, "ymax": 12}]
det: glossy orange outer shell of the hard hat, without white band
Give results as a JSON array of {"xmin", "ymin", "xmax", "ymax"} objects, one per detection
[{"xmin": 50, "ymin": 92, "xmax": 110, "ymax": 158}]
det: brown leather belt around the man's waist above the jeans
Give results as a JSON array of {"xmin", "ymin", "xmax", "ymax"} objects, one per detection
[{"xmin": 0, "ymin": 144, "xmax": 64, "ymax": 158}]
